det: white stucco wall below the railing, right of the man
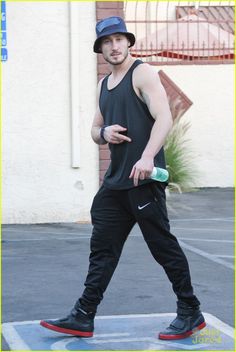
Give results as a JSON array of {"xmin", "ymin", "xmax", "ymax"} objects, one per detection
[{"xmin": 157, "ymin": 65, "xmax": 234, "ymax": 187}]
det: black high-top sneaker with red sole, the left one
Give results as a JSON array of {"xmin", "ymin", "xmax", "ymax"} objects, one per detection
[{"xmin": 40, "ymin": 308, "xmax": 95, "ymax": 337}]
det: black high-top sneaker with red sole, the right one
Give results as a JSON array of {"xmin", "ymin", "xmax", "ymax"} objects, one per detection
[{"xmin": 158, "ymin": 302, "xmax": 206, "ymax": 340}]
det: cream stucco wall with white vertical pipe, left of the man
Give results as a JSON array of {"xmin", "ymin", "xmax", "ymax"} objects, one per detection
[{"xmin": 2, "ymin": 2, "xmax": 98, "ymax": 223}]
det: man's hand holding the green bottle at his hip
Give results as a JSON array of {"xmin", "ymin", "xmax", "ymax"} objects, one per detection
[{"xmin": 129, "ymin": 157, "xmax": 154, "ymax": 186}]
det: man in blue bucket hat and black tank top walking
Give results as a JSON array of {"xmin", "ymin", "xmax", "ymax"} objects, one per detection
[{"xmin": 40, "ymin": 16, "xmax": 206, "ymax": 340}]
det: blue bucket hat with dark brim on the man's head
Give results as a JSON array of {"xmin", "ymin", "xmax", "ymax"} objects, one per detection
[{"xmin": 93, "ymin": 16, "xmax": 135, "ymax": 54}]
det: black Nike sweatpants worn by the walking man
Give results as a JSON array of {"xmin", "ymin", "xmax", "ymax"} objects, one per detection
[{"xmin": 75, "ymin": 182, "xmax": 200, "ymax": 312}]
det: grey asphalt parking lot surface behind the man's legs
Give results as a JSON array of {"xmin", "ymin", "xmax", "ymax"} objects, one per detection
[{"xmin": 2, "ymin": 188, "xmax": 234, "ymax": 350}]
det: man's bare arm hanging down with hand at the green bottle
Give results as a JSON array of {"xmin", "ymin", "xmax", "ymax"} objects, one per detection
[{"xmin": 130, "ymin": 64, "xmax": 173, "ymax": 186}]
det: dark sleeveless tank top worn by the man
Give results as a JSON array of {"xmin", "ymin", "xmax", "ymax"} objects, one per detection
[{"xmin": 99, "ymin": 60, "xmax": 165, "ymax": 190}]
